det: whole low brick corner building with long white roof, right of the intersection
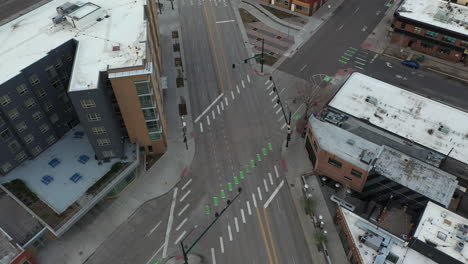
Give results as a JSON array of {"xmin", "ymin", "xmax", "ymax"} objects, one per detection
[{"xmin": 305, "ymin": 73, "xmax": 468, "ymax": 210}]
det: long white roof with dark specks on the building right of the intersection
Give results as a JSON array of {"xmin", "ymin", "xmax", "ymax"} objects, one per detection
[{"xmin": 329, "ymin": 73, "xmax": 468, "ymax": 164}]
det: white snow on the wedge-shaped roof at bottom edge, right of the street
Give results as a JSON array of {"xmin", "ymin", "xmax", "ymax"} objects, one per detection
[{"xmin": 340, "ymin": 207, "xmax": 437, "ymax": 264}]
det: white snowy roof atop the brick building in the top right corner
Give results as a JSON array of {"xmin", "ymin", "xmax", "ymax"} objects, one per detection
[{"xmin": 397, "ymin": 0, "xmax": 468, "ymax": 36}]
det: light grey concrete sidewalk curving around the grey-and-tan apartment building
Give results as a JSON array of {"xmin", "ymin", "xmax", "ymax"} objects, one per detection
[{"xmin": 38, "ymin": 4, "xmax": 195, "ymax": 264}]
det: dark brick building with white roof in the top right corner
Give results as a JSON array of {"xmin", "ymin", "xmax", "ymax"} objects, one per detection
[{"xmin": 391, "ymin": 0, "xmax": 468, "ymax": 66}]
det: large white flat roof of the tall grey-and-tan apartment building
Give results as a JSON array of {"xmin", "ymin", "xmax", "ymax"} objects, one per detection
[{"xmin": 0, "ymin": 0, "xmax": 147, "ymax": 91}]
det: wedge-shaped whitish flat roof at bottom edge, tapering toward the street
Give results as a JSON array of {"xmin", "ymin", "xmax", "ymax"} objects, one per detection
[{"xmin": 340, "ymin": 207, "xmax": 436, "ymax": 264}]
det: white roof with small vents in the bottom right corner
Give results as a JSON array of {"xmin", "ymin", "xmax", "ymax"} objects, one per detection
[{"xmin": 414, "ymin": 202, "xmax": 468, "ymax": 263}]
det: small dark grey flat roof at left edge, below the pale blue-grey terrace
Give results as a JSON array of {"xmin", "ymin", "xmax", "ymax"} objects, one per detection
[{"xmin": 0, "ymin": 189, "xmax": 44, "ymax": 246}]
